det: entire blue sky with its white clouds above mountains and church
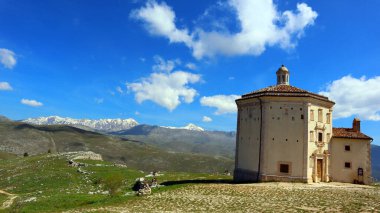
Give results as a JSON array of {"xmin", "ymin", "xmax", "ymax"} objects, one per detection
[{"xmin": 0, "ymin": 0, "xmax": 380, "ymax": 144}]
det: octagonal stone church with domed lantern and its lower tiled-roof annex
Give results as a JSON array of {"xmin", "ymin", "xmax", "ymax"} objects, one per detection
[{"xmin": 234, "ymin": 66, "xmax": 372, "ymax": 184}]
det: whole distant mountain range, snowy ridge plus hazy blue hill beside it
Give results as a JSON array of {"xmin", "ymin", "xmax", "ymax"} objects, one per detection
[{"xmin": 22, "ymin": 116, "xmax": 236, "ymax": 159}]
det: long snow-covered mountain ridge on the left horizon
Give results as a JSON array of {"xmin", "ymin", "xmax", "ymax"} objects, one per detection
[{"xmin": 23, "ymin": 116, "xmax": 138, "ymax": 132}]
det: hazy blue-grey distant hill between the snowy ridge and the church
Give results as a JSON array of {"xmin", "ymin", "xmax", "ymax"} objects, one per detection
[{"xmin": 111, "ymin": 125, "xmax": 236, "ymax": 158}]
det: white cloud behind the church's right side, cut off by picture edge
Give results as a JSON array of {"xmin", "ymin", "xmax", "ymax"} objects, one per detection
[{"xmin": 319, "ymin": 75, "xmax": 380, "ymax": 121}]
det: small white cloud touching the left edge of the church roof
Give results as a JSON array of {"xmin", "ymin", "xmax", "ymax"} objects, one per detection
[{"xmin": 200, "ymin": 95, "xmax": 240, "ymax": 115}]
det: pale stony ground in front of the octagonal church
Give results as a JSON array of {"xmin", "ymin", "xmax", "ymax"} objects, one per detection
[{"xmin": 75, "ymin": 183, "xmax": 380, "ymax": 212}]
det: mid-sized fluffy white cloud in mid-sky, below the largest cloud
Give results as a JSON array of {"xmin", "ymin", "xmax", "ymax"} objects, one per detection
[{"xmin": 127, "ymin": 71, "xmax": 201, "ymax": 111}]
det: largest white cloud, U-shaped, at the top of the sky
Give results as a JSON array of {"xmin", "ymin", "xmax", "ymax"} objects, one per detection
[{"xmin": 131, "ymin": 0, "xmax": 318, "ymax": 59}]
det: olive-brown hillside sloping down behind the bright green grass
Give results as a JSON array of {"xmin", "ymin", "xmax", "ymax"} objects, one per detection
[{"xmin": 0, "ymin": 121, "xmax": 234, "ymax": 172}]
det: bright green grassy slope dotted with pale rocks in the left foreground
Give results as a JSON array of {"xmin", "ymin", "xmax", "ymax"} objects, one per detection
[{"xmin": 0, "ymin": 154, "xmax": 230, "ymax": 212}]
